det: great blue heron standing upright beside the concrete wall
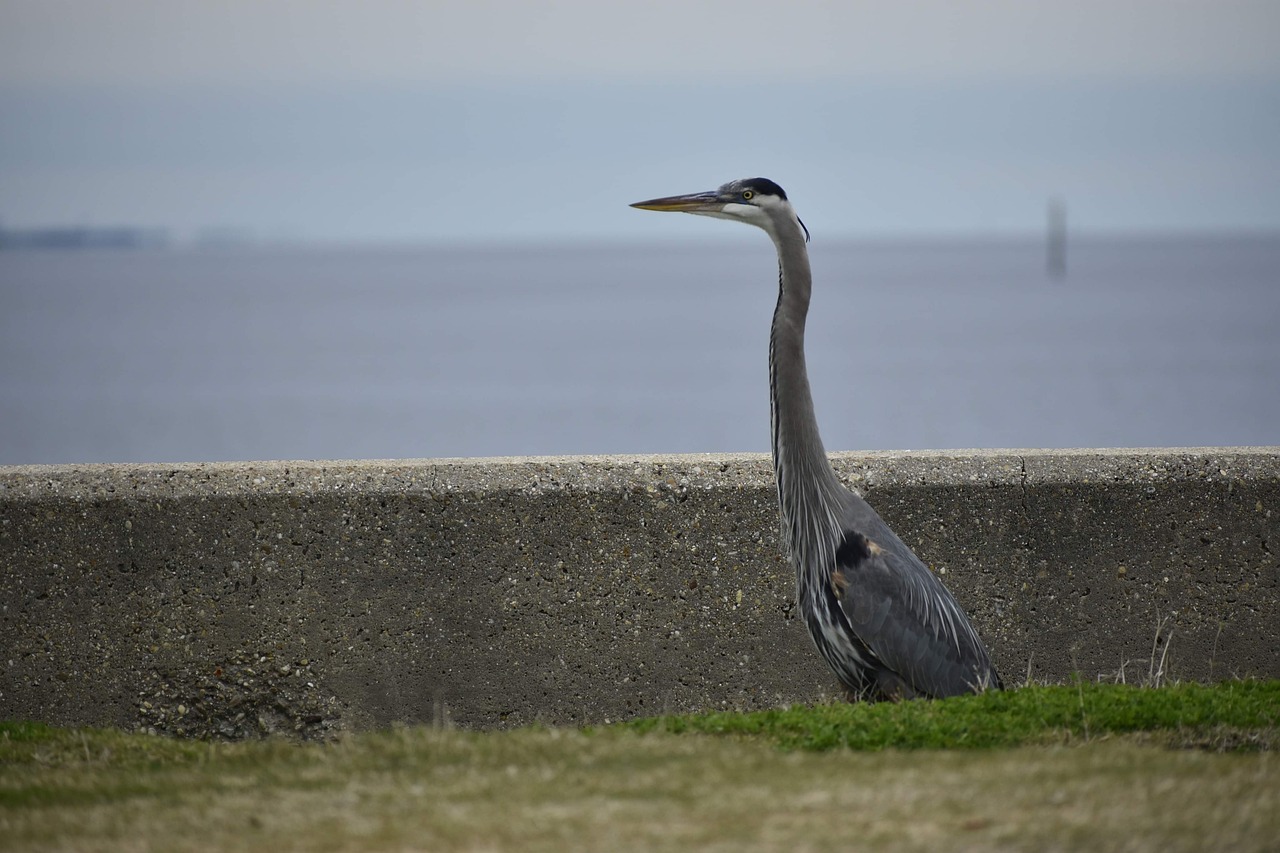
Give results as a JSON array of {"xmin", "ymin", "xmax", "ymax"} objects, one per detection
[{"xmin": 631, "ymin": 178, "xmax": 1001, "ymax": 699}]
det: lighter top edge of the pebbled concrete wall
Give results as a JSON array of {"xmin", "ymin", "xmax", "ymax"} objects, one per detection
[{"xmin": 0, "ymin": 446, "xmax": 1280, "ymax": 501}]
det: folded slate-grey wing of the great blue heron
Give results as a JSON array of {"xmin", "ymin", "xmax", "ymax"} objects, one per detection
[{"xmin": 832, "ymin": 507, "xmax": 1000, "ymax": 697}]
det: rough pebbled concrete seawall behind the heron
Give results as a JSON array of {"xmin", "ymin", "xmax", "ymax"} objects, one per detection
[{"xmin": 0, "ymin": 447, "xmax": 1280, "ymax": 738}]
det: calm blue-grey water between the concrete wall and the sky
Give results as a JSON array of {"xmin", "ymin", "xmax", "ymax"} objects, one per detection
[{"xmin": 0, "ymin": 234, "xmax": 1280, "ymax": 464}]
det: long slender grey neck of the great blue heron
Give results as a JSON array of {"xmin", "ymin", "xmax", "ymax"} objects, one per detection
[{"xmin": 769, "ymin": 224, "xmax": 840, "ymax": 556}]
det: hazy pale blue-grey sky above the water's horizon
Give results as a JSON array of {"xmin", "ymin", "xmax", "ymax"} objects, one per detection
[{"xmin": 0, "ymin": 0, "xmax": 1280, "ymax": 241}]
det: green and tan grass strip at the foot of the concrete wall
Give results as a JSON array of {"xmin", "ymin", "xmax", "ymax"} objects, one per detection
[{"xmin": 0, "ymin": 681, "xmax": 1280, "ymax": 853}]
